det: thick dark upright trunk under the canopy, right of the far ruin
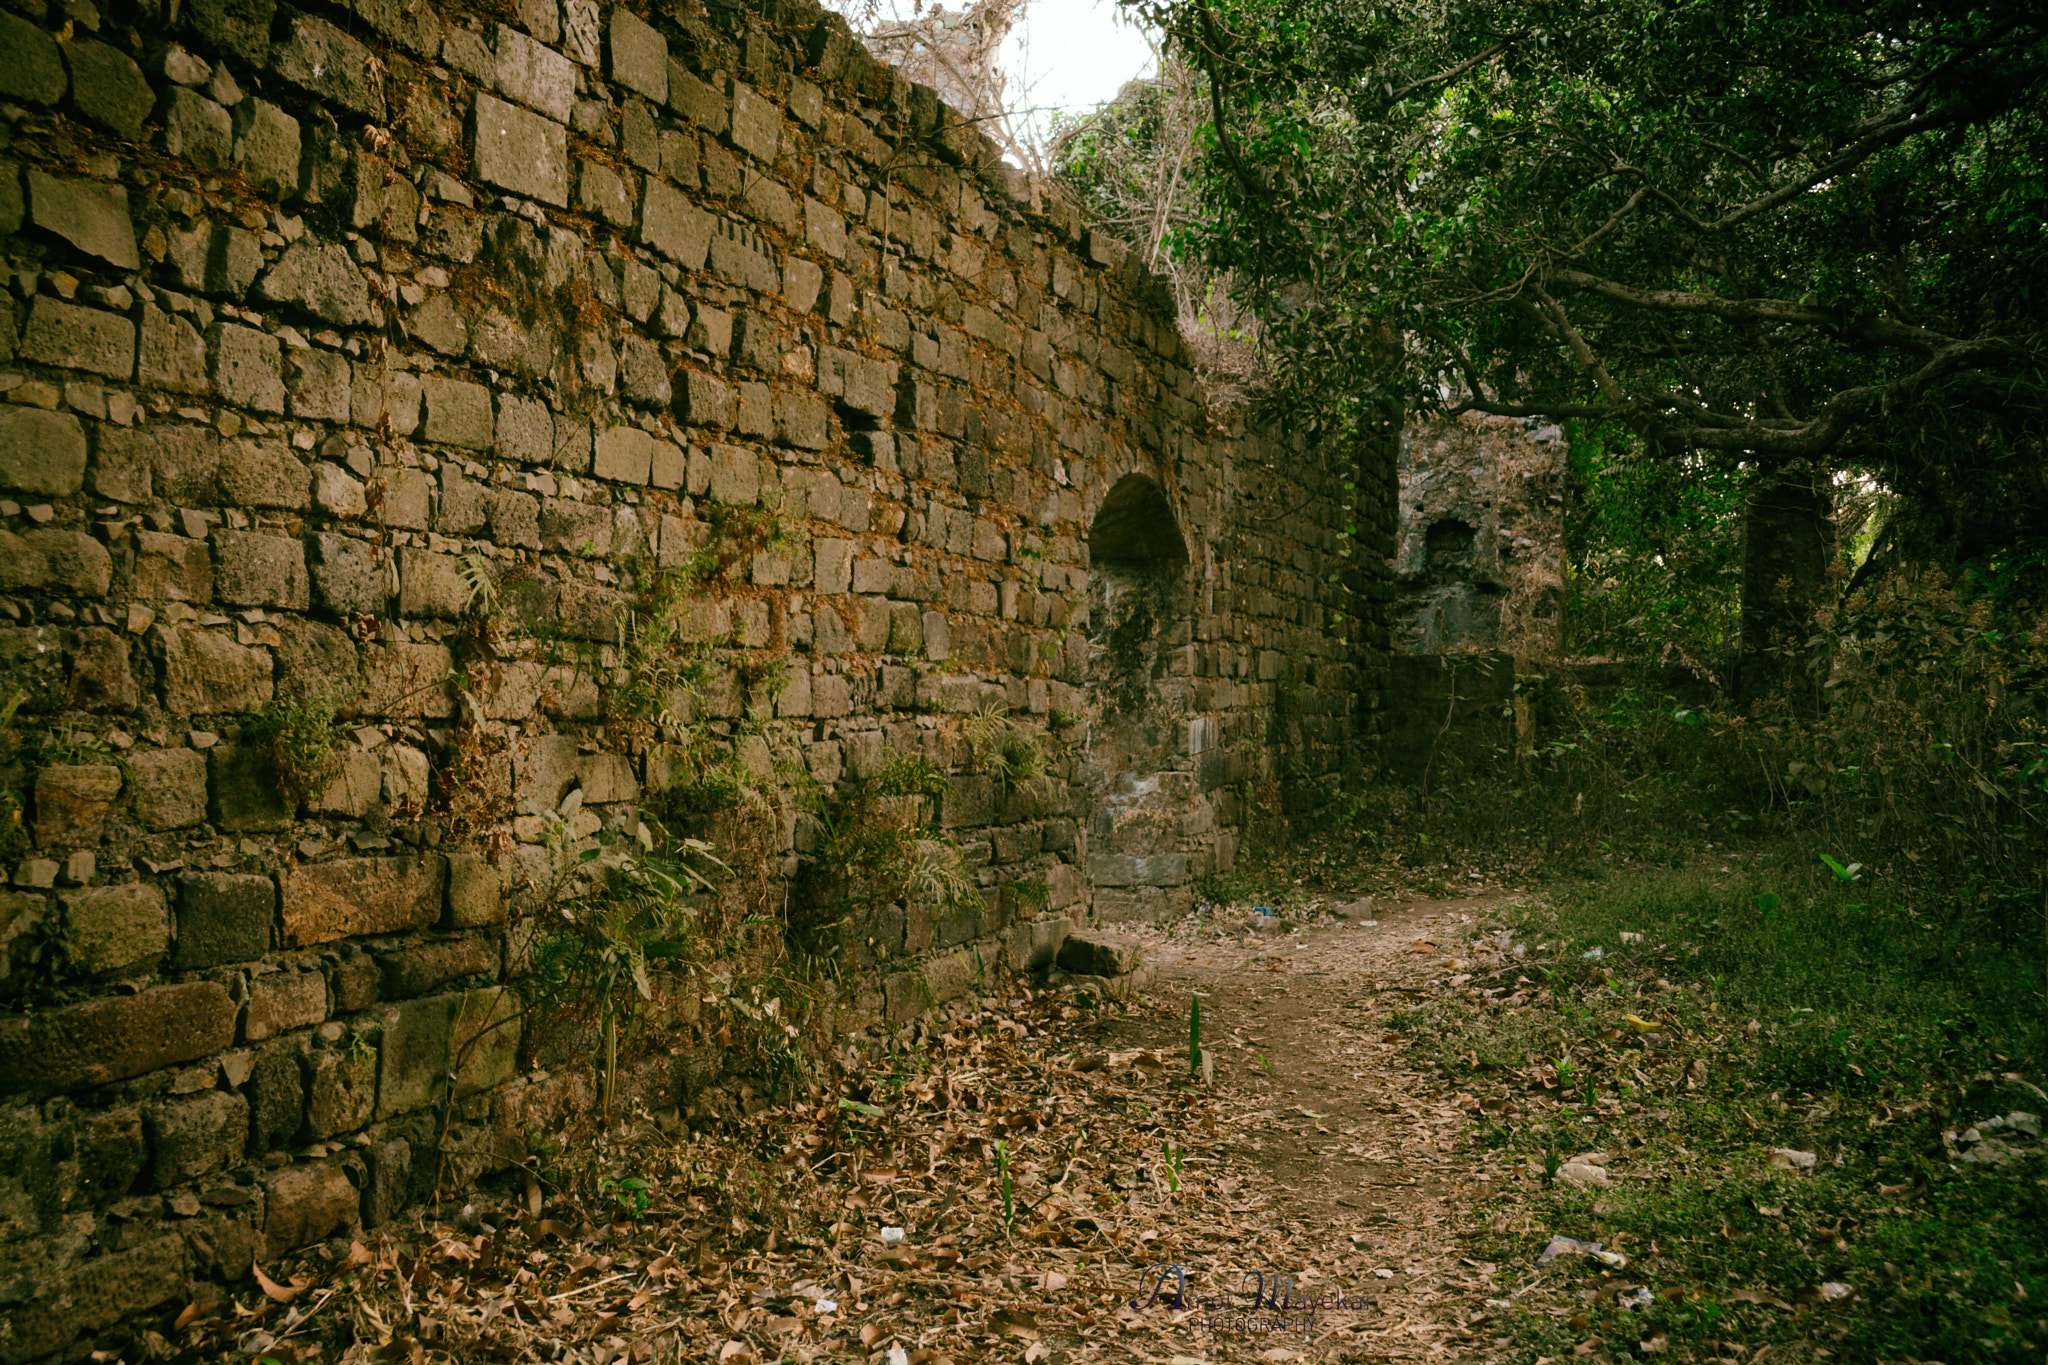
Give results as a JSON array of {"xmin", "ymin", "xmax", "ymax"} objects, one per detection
[{"xmin": 1735, "ymin": 460, "xmax": 1835, "ymax": 714}]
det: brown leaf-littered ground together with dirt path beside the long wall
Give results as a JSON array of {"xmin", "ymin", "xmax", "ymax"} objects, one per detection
[{"xmin": 207, "ymin": 894, "xmax": 1540, "ymax": 1365}]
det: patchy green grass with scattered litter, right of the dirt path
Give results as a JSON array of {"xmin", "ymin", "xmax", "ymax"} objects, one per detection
[{"xmin": 1399, "ymin": 871, "xmax": 2048, "ymax": 1365}]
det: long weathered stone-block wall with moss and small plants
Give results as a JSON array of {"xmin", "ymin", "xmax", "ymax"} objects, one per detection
[{"xmin": 0, "ymin": 0, "xmax": 1393, "ymax": 1363}]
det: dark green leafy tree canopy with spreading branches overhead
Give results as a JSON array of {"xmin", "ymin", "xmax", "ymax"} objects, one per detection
[{"xmin": 1137, "ymin": 0, "xmax": 2048, "ymax": 573}]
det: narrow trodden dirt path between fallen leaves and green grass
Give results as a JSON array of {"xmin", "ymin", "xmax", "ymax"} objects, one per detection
[{"xmin": 1064, "ymin": 894, "xmax": 1520, "ymax": 1361}]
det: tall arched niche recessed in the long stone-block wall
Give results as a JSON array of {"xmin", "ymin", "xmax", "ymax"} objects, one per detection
[{"xmin": 1085, "ymin": 475, "xmax": 1198, "ymax": 919}]
